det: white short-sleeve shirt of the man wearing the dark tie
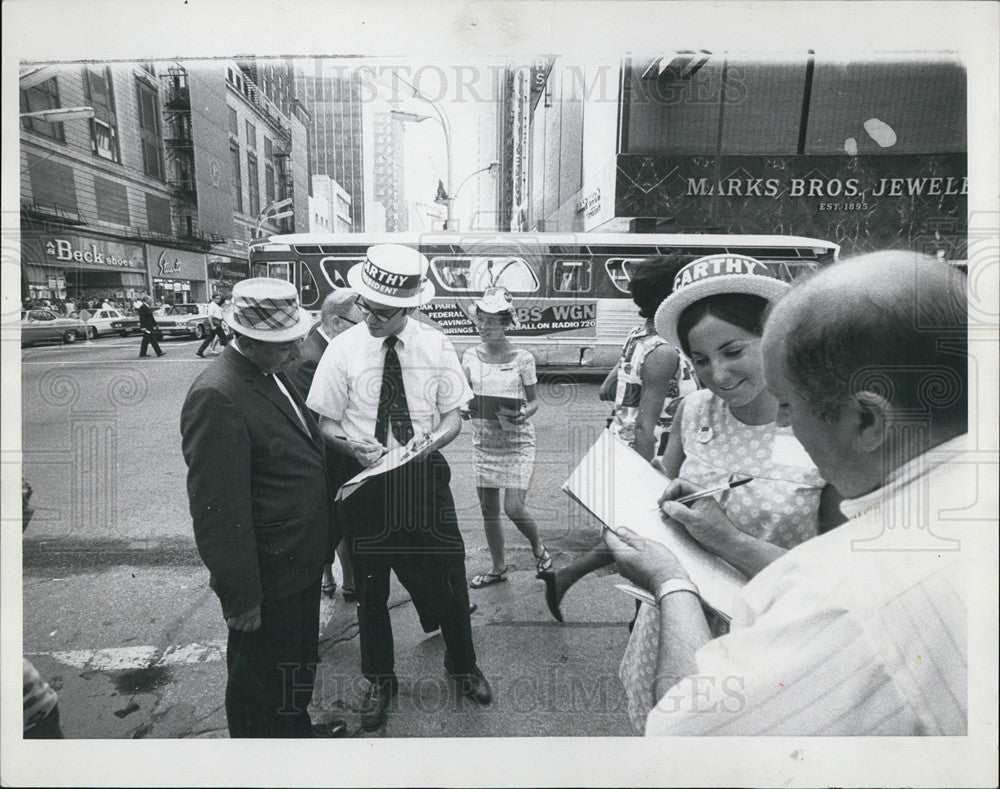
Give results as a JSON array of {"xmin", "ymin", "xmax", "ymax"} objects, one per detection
[{"xmin": 306, "ymin": 318, "xmax": 472, "ymax": 440}]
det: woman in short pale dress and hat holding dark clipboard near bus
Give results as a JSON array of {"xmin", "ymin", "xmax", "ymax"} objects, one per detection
[{"xmin": 462, "ymin": 288, "xmax": 552, "ymax": 589}]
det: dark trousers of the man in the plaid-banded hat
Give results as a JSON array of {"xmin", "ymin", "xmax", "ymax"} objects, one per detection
[{"xmin": 226, "ymin": 578, "xmax": 320, "ymax": 737}]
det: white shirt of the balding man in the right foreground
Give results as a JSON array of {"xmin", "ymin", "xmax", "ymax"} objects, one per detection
[{"xmin": 646, "ymin": 436, "xmax": 972, "ymax": 736}]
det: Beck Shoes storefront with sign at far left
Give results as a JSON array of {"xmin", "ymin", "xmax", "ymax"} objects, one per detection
[{"xmin": 21, "ymin": 233, "xmax": 148, "ymax": 304}]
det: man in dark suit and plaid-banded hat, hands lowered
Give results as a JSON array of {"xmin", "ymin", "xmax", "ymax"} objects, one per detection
[{"xmin": 181, "ymin": 279, "xmax": 346, "ymax": 737}]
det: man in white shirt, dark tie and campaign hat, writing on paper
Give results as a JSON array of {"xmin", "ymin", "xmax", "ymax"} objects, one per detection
[{"xmin": 306, "ymin": 244, "xmax": 492, "ymax": 731}]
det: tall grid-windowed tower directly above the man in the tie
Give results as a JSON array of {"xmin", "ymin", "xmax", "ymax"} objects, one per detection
[{"xmin": 296, "ymin": 58, "xmax": 371, "ymax": 232}]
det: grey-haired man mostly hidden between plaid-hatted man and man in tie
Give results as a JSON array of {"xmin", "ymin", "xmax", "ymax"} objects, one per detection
[{"xmin": 285, "ymin": 288, "xmax": 365, "ymax": 603}]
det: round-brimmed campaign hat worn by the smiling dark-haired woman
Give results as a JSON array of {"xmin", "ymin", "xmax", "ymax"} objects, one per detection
[{"xmin": 654, "ymin": 254, "xmax": 789, "ymax": 347}]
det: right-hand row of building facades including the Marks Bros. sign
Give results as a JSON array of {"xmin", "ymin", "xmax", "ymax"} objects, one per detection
[{"xmin": 503, "ymin": 51, "xmax": 968, "ymax": 259}]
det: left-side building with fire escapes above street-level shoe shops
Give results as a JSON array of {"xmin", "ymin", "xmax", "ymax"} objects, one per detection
[{"xmin": 20, "ymin": 56, "xmax": 308, "ymax": 306}]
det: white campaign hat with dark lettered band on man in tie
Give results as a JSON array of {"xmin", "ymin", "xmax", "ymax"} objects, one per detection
[{"xmin": 347, "ymin": 244, "xmax": 434, "ymax": 307}]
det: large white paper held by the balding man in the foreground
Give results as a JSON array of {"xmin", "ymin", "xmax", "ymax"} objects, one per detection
[{"xmin": 562, "ymin": 430, "xmax": 747, "ymax": 620}]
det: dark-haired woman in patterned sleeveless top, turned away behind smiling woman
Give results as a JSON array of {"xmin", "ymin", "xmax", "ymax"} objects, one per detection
[{"xmin": 539, "ymin": 256, "xmax": 698, "ymax": 622}]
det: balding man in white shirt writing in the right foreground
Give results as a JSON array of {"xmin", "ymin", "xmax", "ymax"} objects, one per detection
[{"xmin": 606, "ymin": 252, "xmax": 972, "ymax": 735}]
